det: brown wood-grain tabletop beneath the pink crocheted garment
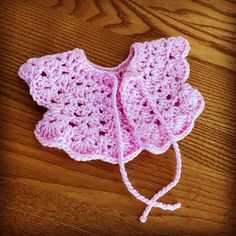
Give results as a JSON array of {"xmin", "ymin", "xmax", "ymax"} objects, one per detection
[{"xmin": 0, "ymin": 0, "xmax": 236, "ymax": 235}]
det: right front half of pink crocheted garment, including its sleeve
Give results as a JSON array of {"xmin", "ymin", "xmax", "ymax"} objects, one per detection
[{"xmin": 122, "ymin": 37, "xmax": 204, "ymax": 149}]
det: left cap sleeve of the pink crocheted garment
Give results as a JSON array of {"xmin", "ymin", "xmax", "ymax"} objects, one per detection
[{"xmin": 18, "ymin": 49, "xmax": 81, "ymax": 108}]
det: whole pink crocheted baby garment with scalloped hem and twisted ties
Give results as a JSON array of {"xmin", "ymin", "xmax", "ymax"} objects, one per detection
[{"xmin": 19, "ymin": 37, "xmax": 204, "ymax": 222}]
